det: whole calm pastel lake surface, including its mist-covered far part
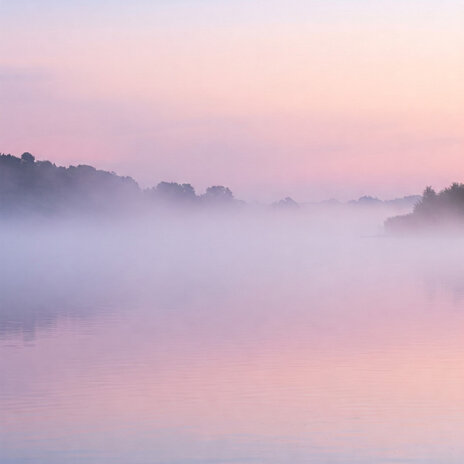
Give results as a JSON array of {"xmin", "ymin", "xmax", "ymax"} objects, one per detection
[{"xmin": 0, "ymin": 218, "xmax": 464, "ymax": 464}]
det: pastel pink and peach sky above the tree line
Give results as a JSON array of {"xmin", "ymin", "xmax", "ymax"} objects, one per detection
[{"xmin": 0, "ymin": 0, "xmax": 464, "ymax": 201}]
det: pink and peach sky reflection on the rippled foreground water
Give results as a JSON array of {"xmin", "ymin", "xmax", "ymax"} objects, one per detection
[{"xmin": 0, "ymin": 264, "xmax": 464, "ymax": 462}]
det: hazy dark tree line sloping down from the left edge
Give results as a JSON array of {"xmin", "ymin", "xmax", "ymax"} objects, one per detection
[{"xmin": 0, "ymin": 152, "xmax": 240, "ymax": 215}]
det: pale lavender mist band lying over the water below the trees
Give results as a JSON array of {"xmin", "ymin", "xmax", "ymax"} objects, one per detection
[{"xmin": 0, "ymin": 208, "xmax": 464, "ymax": 342}]
